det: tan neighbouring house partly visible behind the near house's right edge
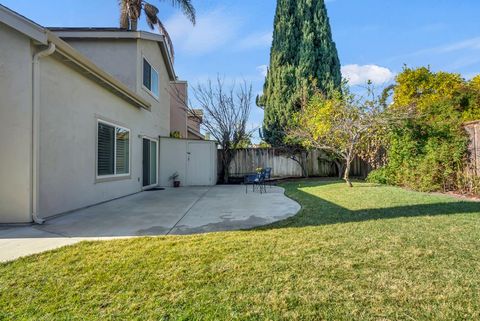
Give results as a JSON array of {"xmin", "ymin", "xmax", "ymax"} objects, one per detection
[{"xmin": 170, "ymin": 81, "xmax": 205, "ymax": 140}]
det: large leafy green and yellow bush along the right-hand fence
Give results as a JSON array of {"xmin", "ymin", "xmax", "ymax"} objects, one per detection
[{"xmin": 368, "ymin": 68, "xmax": 480, "ymax": 192}]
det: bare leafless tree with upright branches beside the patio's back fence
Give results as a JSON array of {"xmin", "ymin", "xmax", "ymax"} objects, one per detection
[{"xmin": 172, "ymin": 76, "xmax": 254, "ymax": 183}]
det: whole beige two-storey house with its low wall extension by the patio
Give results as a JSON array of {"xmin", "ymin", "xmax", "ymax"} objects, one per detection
[{"xmin": 0, "ymin": 5, "xmax": 216, "ymax": 223}]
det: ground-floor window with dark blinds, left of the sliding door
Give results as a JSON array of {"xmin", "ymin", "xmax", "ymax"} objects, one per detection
[{"xmin": 97, "ymin": 121, "xmax": 130, "ymax": 177}]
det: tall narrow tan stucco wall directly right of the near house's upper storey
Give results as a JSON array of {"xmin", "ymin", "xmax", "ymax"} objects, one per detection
[{"xmin": 170, "ymin": 82, "xmax": 188, "ymax": 138}]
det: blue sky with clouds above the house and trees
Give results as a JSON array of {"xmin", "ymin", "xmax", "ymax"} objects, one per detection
[{"xmin": 4, "ymin": 0, "xmax": 480, "ymax": 135}]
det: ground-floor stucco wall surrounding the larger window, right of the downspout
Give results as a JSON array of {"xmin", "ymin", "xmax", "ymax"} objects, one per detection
[{"xmin": 40, "ymin": 57, "xmax": 167, "ymax": 217}]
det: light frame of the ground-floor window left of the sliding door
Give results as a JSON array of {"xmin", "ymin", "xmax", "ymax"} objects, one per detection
[{"xmin": 95, "ymin": 118, "xmax": 132, "ymax": 183}]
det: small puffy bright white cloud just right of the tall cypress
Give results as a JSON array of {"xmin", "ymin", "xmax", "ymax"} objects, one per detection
[{"xmin": 342, "ymin": 64, "xmax": 395, "ymax": 85}]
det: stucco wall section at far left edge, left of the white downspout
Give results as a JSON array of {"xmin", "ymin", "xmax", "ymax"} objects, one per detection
[{"xmin": 0, "ymin": 23, "xmax": 33, "ymax": 223}]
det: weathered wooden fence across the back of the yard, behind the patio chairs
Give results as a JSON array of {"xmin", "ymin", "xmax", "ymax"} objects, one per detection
[{"xmin": 218, "ymin": 148, "xmax": 371, "ymax": 177}]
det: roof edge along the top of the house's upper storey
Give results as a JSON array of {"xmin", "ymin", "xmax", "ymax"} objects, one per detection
[{"xmin": 48, "ymin": 27, "xmax": 177, "ymax": 81}]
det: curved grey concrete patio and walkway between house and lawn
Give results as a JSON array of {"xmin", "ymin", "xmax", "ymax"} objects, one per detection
[{"xmin": 0, "ymin": 185, "xmax": 300, "ymax": 262}]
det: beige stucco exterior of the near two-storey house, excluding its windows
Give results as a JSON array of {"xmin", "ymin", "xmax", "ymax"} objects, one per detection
[{"xmin": 0, "ymin": 6, "xmax": 174, "ymax": 223}]
